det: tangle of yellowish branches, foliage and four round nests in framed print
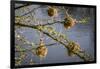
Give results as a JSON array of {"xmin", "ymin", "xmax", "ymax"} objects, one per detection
[{"xmin": 15, "ymin": 4, "xmax": 93, "ymax": 66}]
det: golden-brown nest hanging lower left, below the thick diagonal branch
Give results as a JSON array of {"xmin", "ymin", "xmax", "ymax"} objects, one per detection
[{"xmin": 36, "ymin": 41, "xmax": 48, "ymax": 58}]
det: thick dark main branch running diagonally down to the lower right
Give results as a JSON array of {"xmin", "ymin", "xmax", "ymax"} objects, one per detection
[{"xmin": 15, "ymin": 24, "xmax": 93, "ymax": 61}]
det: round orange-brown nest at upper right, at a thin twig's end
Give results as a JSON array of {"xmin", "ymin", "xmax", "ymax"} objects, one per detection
[{"xmin": 64, "ymin": 16, "xmax": 76, "ymax": 29}]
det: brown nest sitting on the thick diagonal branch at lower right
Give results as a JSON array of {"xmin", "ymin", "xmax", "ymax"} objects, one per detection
[{"xmin": 68, "ymin": 41, "xmax": 81, "ymax": 56}]
